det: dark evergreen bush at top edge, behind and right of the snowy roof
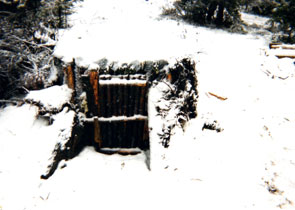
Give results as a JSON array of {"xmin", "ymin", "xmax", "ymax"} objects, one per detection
[{"xmin": 175, "ymin": 0, "xmax": 241, "ymax": 27}]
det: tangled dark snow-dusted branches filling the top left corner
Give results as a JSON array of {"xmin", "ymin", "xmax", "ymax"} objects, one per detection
[{"xmin": 0, "ymin": 0, "xmax": 75, "ymax": 99}]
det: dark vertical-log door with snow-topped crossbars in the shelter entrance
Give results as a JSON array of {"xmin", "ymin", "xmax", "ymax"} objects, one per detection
[{"xmin": 82, "ymin": 71, "xmax": 149, "ymax": 151}]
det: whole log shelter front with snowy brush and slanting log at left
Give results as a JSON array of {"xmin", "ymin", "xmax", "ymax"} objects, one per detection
[{"xmin": 42, "ymin": 59, "xmax": 198, "ymax": 179}]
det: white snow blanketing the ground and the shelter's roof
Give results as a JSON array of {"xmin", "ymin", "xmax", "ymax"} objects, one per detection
[{"xmin": 0, "ymin": 0, "xmax": 295, "ymax": 210}]
